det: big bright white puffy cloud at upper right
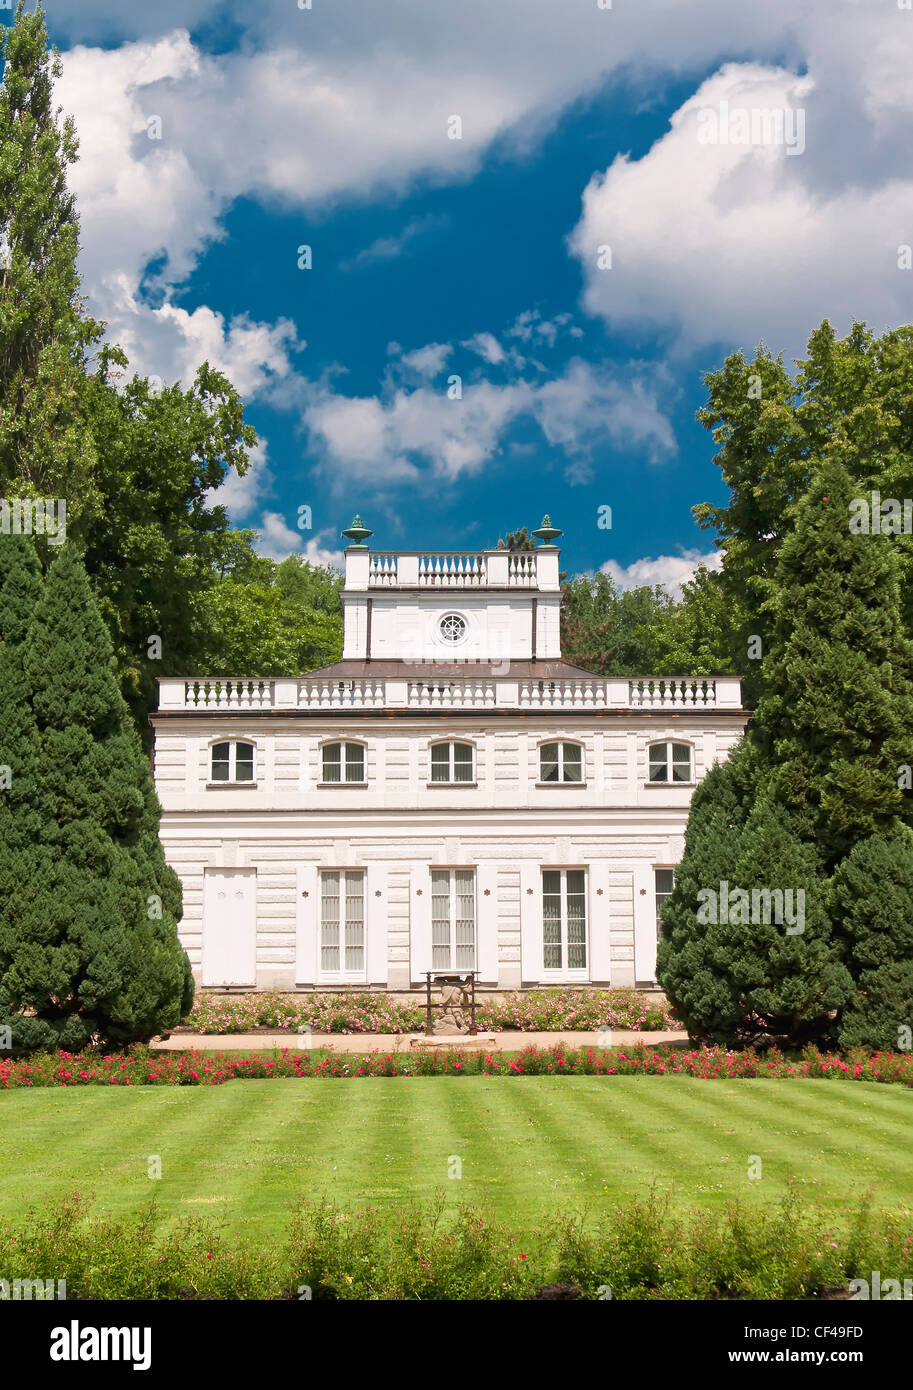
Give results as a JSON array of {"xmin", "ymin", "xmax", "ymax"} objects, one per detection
[{"xmin": 570, "ymin": 60, "xmax": 913, "ymax": 353}]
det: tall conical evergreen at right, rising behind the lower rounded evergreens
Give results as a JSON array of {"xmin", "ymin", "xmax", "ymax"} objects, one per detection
[{"xmin": 752, "ymin": 459, "xmax": 913, "ymax": 872}]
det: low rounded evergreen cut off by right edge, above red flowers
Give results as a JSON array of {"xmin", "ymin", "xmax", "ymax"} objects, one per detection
[{"xmin": 831, "ymin": 826, "xmax": 913, "ymax": 1051}]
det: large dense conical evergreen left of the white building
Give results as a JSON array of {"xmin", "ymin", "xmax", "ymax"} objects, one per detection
[{"xmin": 0, "ymin": 548, "xmax": 193, "ymax": 1051}]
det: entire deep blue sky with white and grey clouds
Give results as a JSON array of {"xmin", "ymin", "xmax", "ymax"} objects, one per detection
[{"xmin": 8, "ymin": 0, "xmax": 913, "ymax": 591}]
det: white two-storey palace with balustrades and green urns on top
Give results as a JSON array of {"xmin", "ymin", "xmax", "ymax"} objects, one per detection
[{"xmin": 151, "ymin": 517, "xmax": 748, "ymax": 991}]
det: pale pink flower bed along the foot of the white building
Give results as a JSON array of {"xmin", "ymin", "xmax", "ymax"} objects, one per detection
[{"xmin": 186, "ymin": 990, "xmax": 678, "ymax": 1033}]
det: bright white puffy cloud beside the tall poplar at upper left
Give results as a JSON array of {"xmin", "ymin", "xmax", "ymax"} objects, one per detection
[{"xmin": 57, "ymin": 32, "xmax": 303, "ymax": 398}]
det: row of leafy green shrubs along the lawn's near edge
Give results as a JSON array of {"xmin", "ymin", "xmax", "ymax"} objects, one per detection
[{"xmin": 0, "ymin": 1191, "xmax": 913, "ymax": 1301}]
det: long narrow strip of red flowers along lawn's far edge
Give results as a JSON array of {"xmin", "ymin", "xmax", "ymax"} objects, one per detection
[{"xmin": 0, "ymin": 1044, "xmax": 913, "ymax": 1090}]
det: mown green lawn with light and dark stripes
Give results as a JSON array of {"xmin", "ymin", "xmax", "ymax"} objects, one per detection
[{"xmin": 0, "ymin": 1076, "xmax": 913, "ymax": 1232}]
